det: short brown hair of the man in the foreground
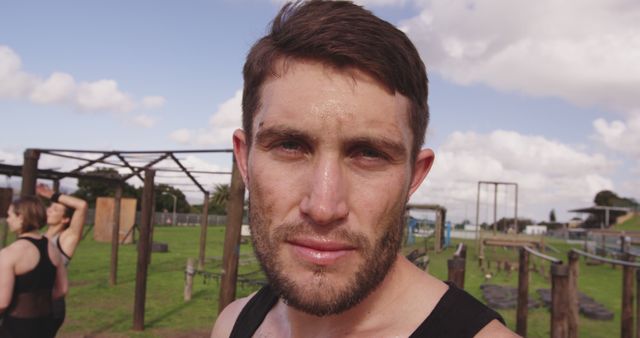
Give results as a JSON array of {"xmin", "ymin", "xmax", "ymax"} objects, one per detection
[{"xmin": 242, "ymin": 0, "xmax": 429, "ymax": 159}]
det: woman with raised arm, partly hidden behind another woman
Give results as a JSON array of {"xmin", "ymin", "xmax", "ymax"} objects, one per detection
[{"xmin": 36, "ymin": 184, "xmax": 88, "ymax": 332}]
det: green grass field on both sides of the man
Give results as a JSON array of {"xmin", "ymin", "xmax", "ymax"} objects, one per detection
[{"xmin": 2, "ymin": 226, "xmax": 622, "ymax": 337}]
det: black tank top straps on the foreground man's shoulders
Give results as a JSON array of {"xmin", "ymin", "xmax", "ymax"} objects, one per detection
[{"xmin": 229, "ymin": 282, "xmax": 504, "ymax": 338}]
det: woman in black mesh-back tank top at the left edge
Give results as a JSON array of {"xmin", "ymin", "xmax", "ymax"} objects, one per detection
[{"xmin": 0, "ymin": 196, "xmax": 68, "ymax": 338}]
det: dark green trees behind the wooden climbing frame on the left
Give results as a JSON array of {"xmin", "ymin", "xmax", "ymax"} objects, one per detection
[{"xmin": 72, "ymin": 168, "xmax": 229, "ymax": 215}]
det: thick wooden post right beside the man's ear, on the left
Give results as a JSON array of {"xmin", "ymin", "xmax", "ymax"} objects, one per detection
[{"xmin": 218, "ymin": 157, "xmax": 244, "ymax": 313}]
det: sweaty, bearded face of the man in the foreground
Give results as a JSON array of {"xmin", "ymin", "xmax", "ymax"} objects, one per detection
[{"xmin": 234, "ymin": 61, "xmax": 433, "ymax": 316}]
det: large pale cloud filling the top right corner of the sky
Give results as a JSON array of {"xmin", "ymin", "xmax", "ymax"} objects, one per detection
[{"xmin": 401, "ymin": 0, "xmax": 640, "ymax": 112}]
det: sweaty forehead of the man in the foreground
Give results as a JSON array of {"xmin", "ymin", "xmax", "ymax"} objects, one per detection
[{"xmin": 252, "ymin": 61, "xmax": 411, "ymax": 142}]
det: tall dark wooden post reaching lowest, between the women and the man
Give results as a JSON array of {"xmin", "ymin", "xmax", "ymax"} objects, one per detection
[{"xmin": 133, "ymin": 169, "xmax": 155, "ymax": 331}]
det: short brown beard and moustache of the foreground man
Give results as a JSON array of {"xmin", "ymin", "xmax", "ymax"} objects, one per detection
[{"xmin": 249, "ymin": 190, "xmax": 405, "ymax": 316}]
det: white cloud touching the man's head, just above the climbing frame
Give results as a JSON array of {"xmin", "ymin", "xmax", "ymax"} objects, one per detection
[{"xmin": 169, "ymin": 90, "xmax": 242, "ymax": 148}]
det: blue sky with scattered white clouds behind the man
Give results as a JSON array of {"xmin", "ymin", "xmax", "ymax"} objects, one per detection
[{"xmin": 0, "ymin": 0, "xmax": 640, "ymax": 221}]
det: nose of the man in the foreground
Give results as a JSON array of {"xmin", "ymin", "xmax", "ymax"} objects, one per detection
[{"xmin": 300, "ymin": 158, "xmax": 349, "ymax": 225}]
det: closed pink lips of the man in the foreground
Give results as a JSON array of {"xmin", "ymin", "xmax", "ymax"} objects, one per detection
[{"xmin": 288, "ymin": 239, "xmax": 356, "ymax": 266}]
